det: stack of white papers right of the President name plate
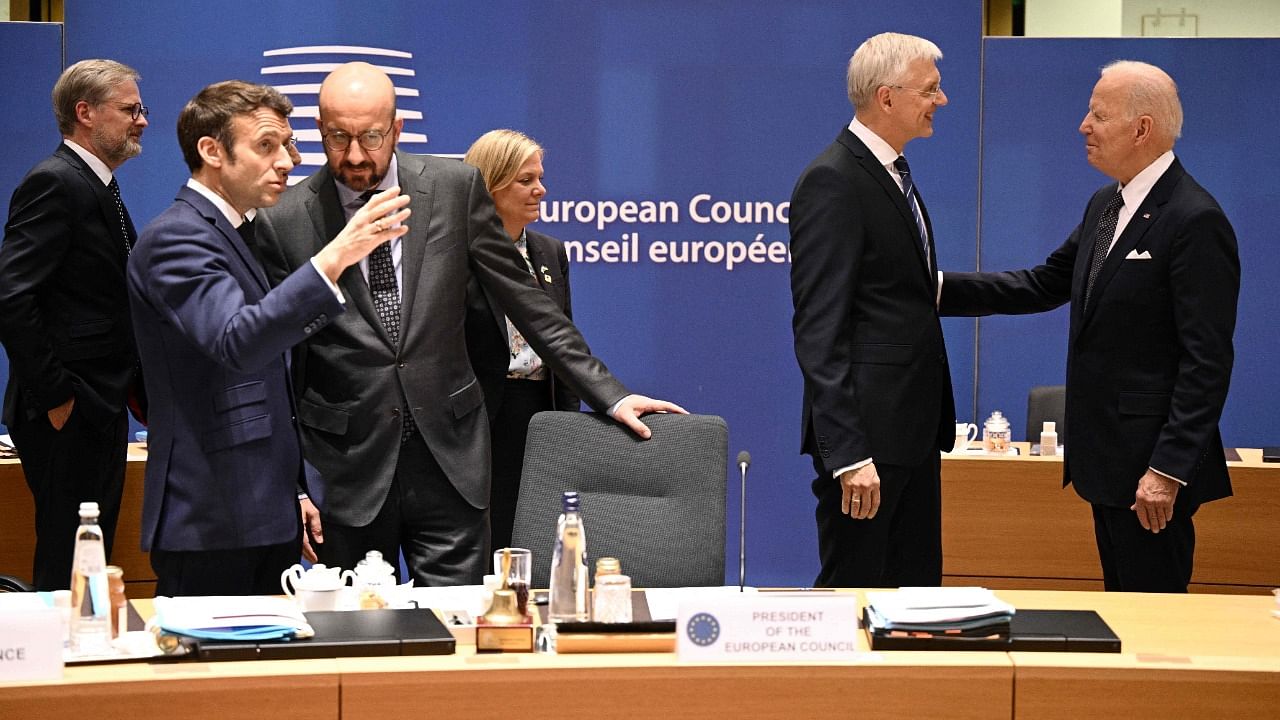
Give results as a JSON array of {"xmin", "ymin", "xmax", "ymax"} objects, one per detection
[{"xmin": 867, "ymin": 588, "xmax": 1014, "ymax": 637}]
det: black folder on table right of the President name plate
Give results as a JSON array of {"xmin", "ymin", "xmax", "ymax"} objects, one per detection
[{"xmin": 863, "ymin": 610, "xmax": 1120, "ymax": 652}]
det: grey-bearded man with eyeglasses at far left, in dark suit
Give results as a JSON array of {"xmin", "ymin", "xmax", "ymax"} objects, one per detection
[{"xmin": 0, "ymin": 60, "xmax": 147, "ymax": 591}]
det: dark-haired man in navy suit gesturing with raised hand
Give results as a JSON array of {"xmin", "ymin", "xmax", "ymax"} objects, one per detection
[{"xmin": 128, "ymin": 81, "xmax": 410, "ymax": 596}]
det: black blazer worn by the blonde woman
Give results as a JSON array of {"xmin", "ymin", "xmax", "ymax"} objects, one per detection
[{"xmin": 467, "ymin": 229, "xmax": 581, "ymax": 418}]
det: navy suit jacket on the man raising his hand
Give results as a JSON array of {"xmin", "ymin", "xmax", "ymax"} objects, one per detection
[{"xmin": 128, "ymin": 187, "xmax": 343, "ymax": 551}]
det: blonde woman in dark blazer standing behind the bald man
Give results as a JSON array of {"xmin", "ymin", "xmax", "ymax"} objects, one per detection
[{"xmin": 465, "ymin": 129, "xmax": 580, "ymax": 548}]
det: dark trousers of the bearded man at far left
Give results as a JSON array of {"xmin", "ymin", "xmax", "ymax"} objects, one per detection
[{"xmin": 9, "ymin": 407, "xmax": 129, "ymax": 591}]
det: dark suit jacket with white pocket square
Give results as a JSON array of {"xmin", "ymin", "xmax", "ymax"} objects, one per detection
[{"xmin": 941, "ymin": 160, "xmax": 1240, "ymax": 509}]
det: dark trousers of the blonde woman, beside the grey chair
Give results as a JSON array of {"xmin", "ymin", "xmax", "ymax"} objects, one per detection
[{"xmin": 489, "ymin": 379, "xmax": 552, "ymax": 550}]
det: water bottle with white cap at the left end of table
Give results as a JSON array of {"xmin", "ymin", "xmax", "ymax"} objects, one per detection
[{"xmin": 70, "ymin": 502, "xmax": 111, "ymax": 655}]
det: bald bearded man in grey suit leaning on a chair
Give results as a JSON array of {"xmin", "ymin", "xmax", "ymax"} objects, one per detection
[{"xmin": 259, "ymin": 63, "xmax": 682, "ymax": 585}]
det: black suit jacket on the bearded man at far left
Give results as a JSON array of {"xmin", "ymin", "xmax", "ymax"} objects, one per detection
[{"xmin": 0, "ymin": 145, "xmax": 137, "ymax": 427}]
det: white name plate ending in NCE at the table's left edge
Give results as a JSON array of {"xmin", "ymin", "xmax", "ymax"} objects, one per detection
[{"xmin": 0, "ymin": 593, "xmax": 63, "ymax": 682}]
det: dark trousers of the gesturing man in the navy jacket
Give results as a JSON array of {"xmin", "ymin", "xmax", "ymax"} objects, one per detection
[{"xmin": 151, "ymin": 532, "xmax": 302, "ymax": 597}]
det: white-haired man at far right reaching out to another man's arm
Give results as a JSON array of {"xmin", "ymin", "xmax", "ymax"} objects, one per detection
[{"xmin": 941, "ymin": 61, "xmax": 1240, "ymax": 592}]
